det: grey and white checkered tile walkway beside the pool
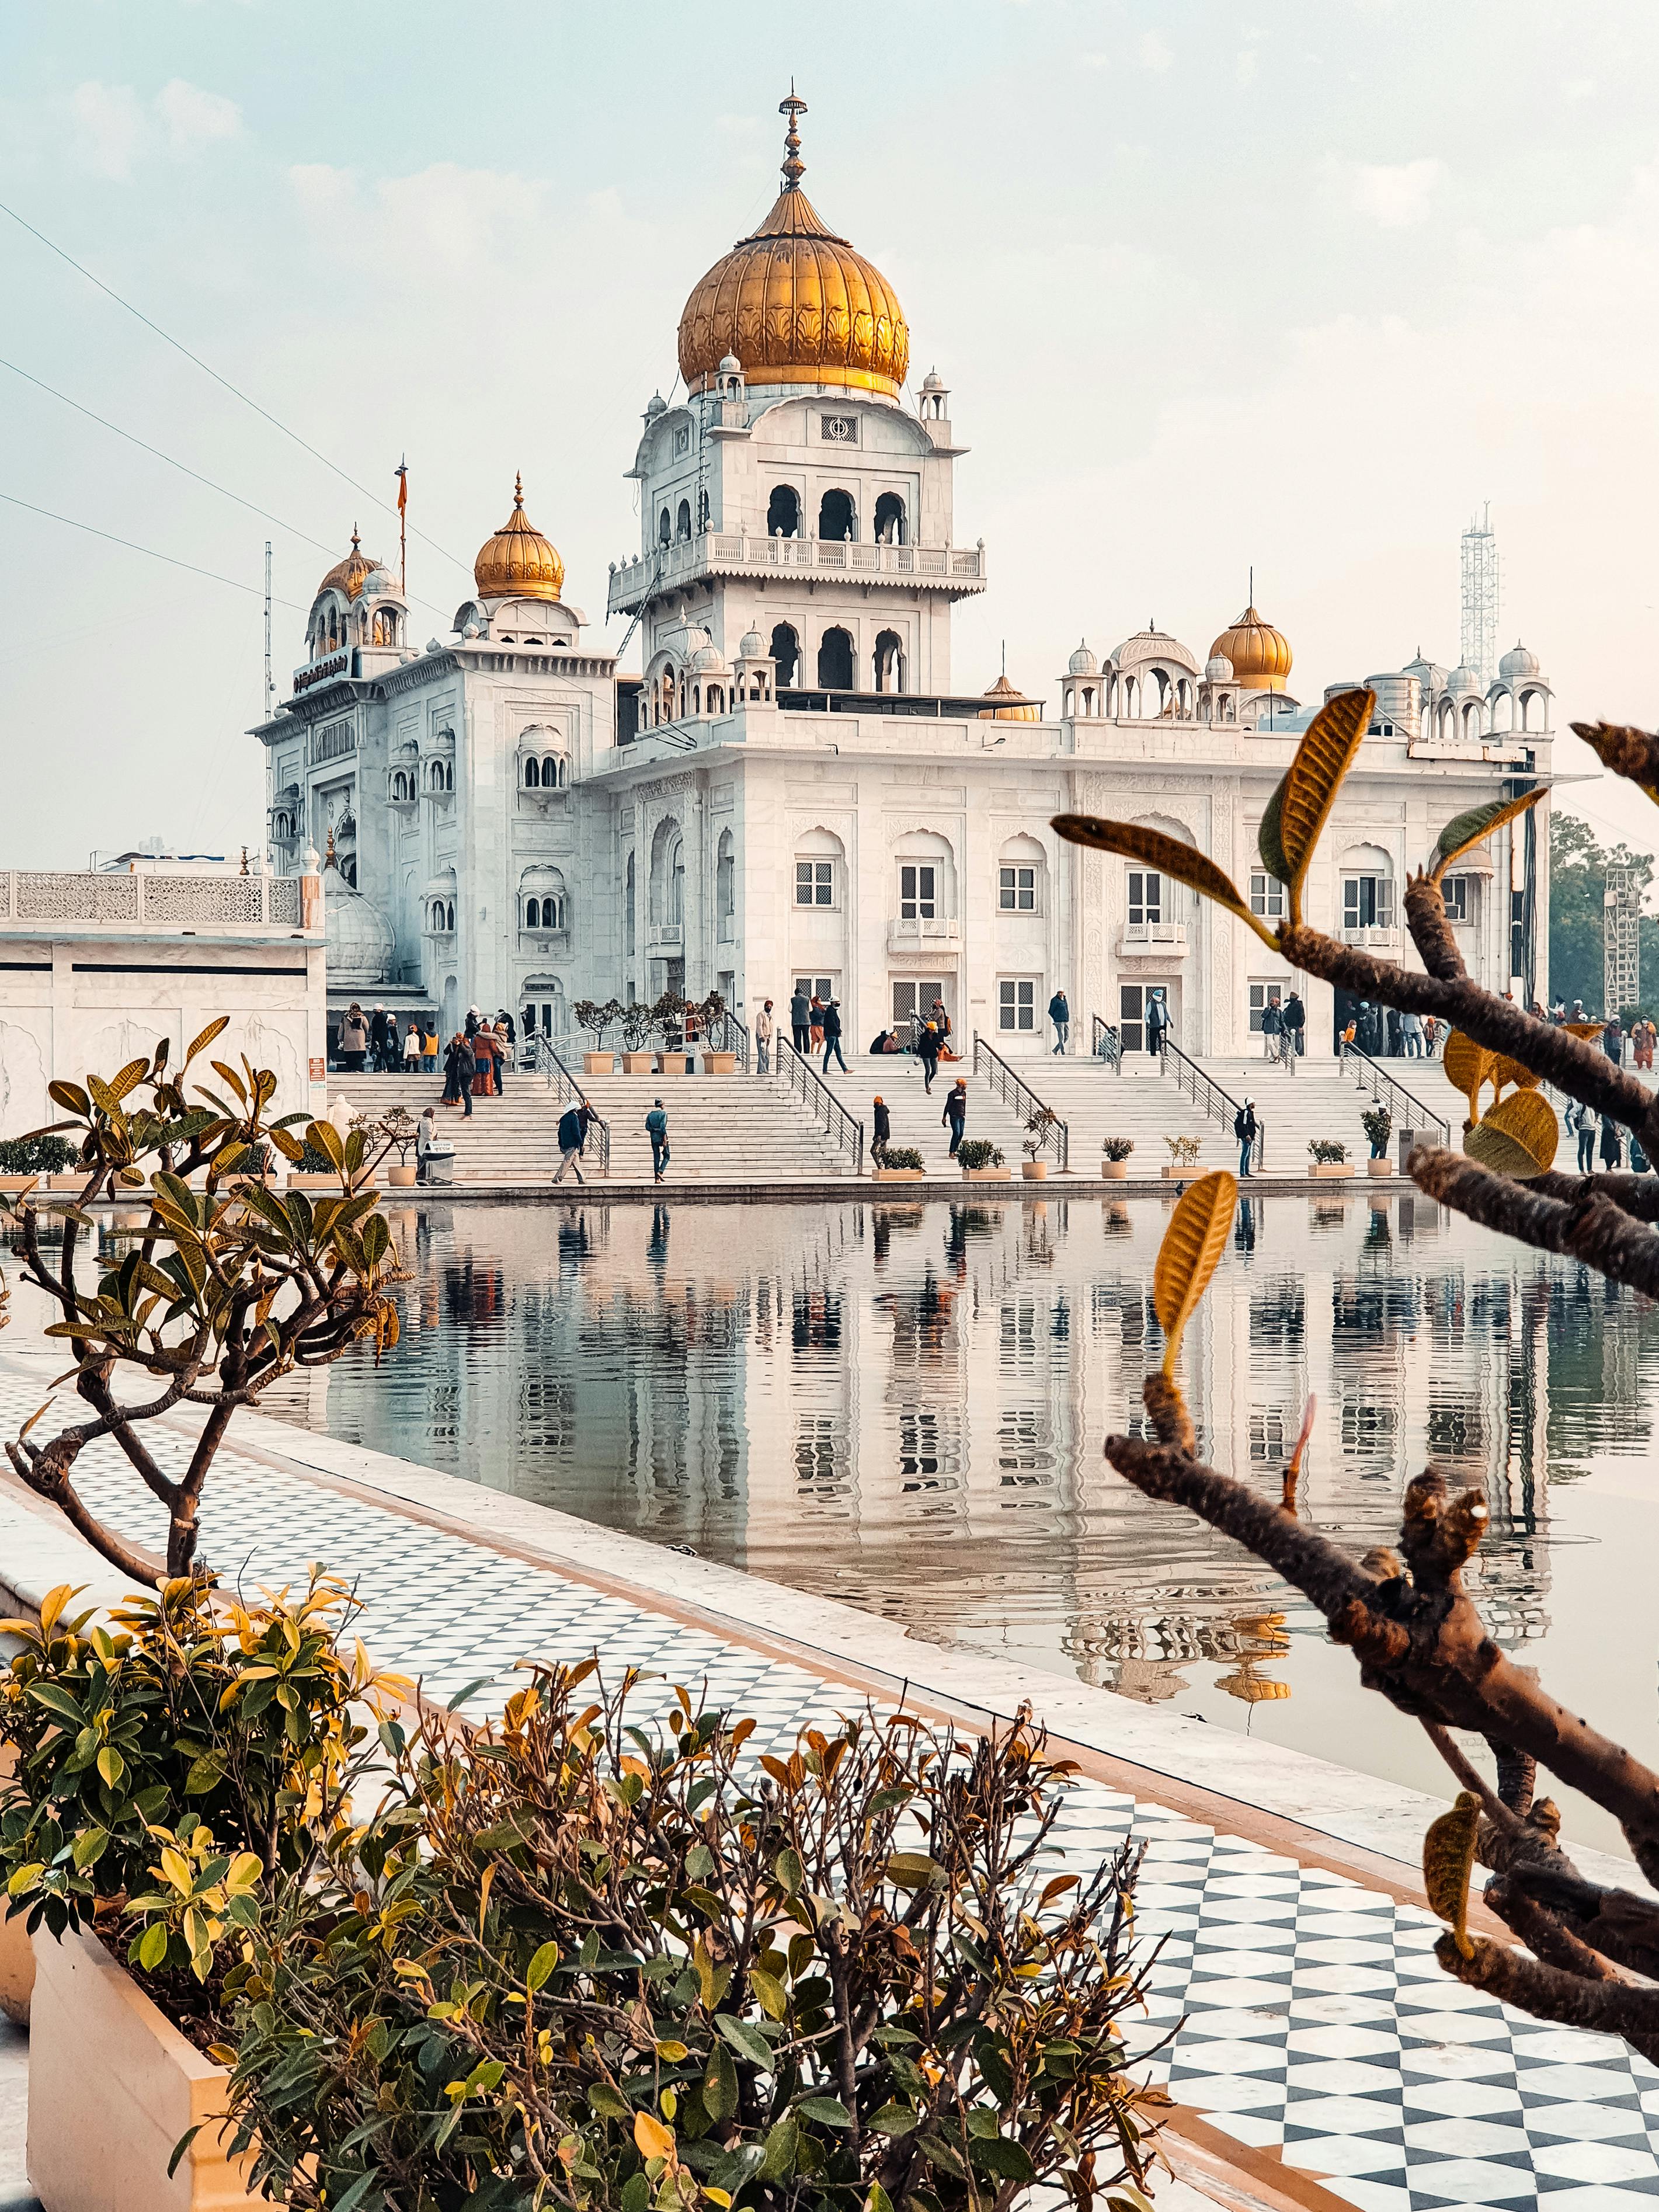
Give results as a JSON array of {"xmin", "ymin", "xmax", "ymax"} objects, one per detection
[{"xmin": 0, "ymin": 1373, "xmax": 1659, "ymax": 2212}]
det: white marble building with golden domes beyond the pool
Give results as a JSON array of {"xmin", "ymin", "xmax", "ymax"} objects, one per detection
[{"xmin": 256, "ymin": 98, "xmax": 1550, "ymax": 1055}]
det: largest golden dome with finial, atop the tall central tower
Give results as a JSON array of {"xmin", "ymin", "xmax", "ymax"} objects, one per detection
[{"xmin": 679, "ymin": 86, "xmax": 909, "ymax": 398}]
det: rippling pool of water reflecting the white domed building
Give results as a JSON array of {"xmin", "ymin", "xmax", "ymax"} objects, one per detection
[{"xmin": 256, "ymin": 1185, "xmax": 1659, "ymax": 1847}]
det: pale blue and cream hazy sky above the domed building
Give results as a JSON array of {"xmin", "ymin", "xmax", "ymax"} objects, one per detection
[{"xmin": 0, "ymin": 0, "xmax": 1659, "ymax": 867}]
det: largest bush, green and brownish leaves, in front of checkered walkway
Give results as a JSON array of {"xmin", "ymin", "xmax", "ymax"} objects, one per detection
[{"xmin": 230, "ymin": 1661, "xmax": 1161, "ymax": 2212}]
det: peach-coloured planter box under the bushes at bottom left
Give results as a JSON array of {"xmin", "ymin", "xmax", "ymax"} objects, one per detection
[{"xmin": 29, "ymin": 1931, "xmax": 255, "ymax": 2212}]
